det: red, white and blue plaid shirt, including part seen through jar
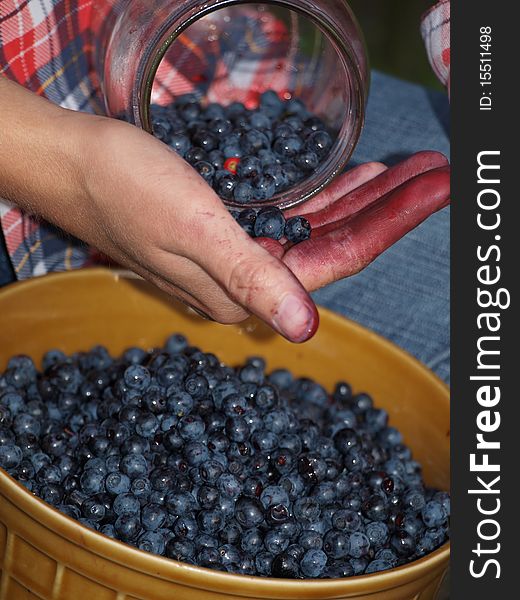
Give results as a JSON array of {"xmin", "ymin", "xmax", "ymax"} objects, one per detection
[{"xmin": 0, "ymin": 0, "xmax": 450, "ymax": 279}]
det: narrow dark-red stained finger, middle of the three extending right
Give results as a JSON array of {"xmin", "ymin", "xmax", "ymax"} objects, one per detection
[{"xmin": 306, "ymin": 152, "xmax": 448, "ymax": 231}]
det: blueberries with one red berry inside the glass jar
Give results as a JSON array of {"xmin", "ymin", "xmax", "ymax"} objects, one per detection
[{"xmin": 150, "ymin": 90, "xmax": 333, "ymax": 205}]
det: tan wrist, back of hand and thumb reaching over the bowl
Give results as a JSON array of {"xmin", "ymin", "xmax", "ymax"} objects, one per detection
[{"xmin": 0, "ymin": 81, "xmax": 318, "ymax": 342}]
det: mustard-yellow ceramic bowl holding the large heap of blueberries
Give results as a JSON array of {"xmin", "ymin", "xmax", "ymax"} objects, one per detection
[{"xmin": 0, "ymin": 270, "xmax": 449, "ymax": 600}]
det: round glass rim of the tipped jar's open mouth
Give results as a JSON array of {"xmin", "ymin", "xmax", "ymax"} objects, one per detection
[{"xmin": 136, "ymin": 0, "xmax": 370, "ymax": 209}]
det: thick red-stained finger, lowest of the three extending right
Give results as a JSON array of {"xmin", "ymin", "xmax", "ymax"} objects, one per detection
[{"xmin": 283, "ymin": 167, "xmax": 450, "ymax": 290}]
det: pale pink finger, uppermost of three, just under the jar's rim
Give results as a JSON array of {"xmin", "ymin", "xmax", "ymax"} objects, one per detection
[{"xmin": 286, "ymin": 162, "xmax": 387, "ymax": 218}]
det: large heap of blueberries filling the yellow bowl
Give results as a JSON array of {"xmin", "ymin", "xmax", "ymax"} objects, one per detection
[{"xmin": 0, "ymin": 334, "xmax": 450, "ymax": 578}]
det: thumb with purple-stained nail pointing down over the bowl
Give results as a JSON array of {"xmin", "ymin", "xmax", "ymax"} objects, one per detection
[{"xmin": 196, "ymin": 209, "xmax": 319, "ymax": 342}]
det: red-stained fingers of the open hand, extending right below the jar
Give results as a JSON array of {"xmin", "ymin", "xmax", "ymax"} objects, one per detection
[{"xmin": 260, "ymin": 152, "xmax": 450, "ymax": 291}]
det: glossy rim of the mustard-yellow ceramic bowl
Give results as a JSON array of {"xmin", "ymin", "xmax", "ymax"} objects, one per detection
[{"xmin": 0, "ymin": 268, "xmax": 451, "ymax": 598}]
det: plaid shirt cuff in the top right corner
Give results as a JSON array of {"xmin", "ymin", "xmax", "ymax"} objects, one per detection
[{"xmin": 421, "ymin": 0, "xmax": 450, "ymax": 90}]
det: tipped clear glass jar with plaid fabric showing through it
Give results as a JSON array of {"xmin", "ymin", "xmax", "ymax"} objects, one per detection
[{"xmin": 94, "ymin": 0, "xmax": 369, "ymax": 208}]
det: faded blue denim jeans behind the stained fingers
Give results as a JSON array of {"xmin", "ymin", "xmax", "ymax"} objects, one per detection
[{"xmin": 0, "ymin": 73, "xmax": 449, "ymax": 380}]
